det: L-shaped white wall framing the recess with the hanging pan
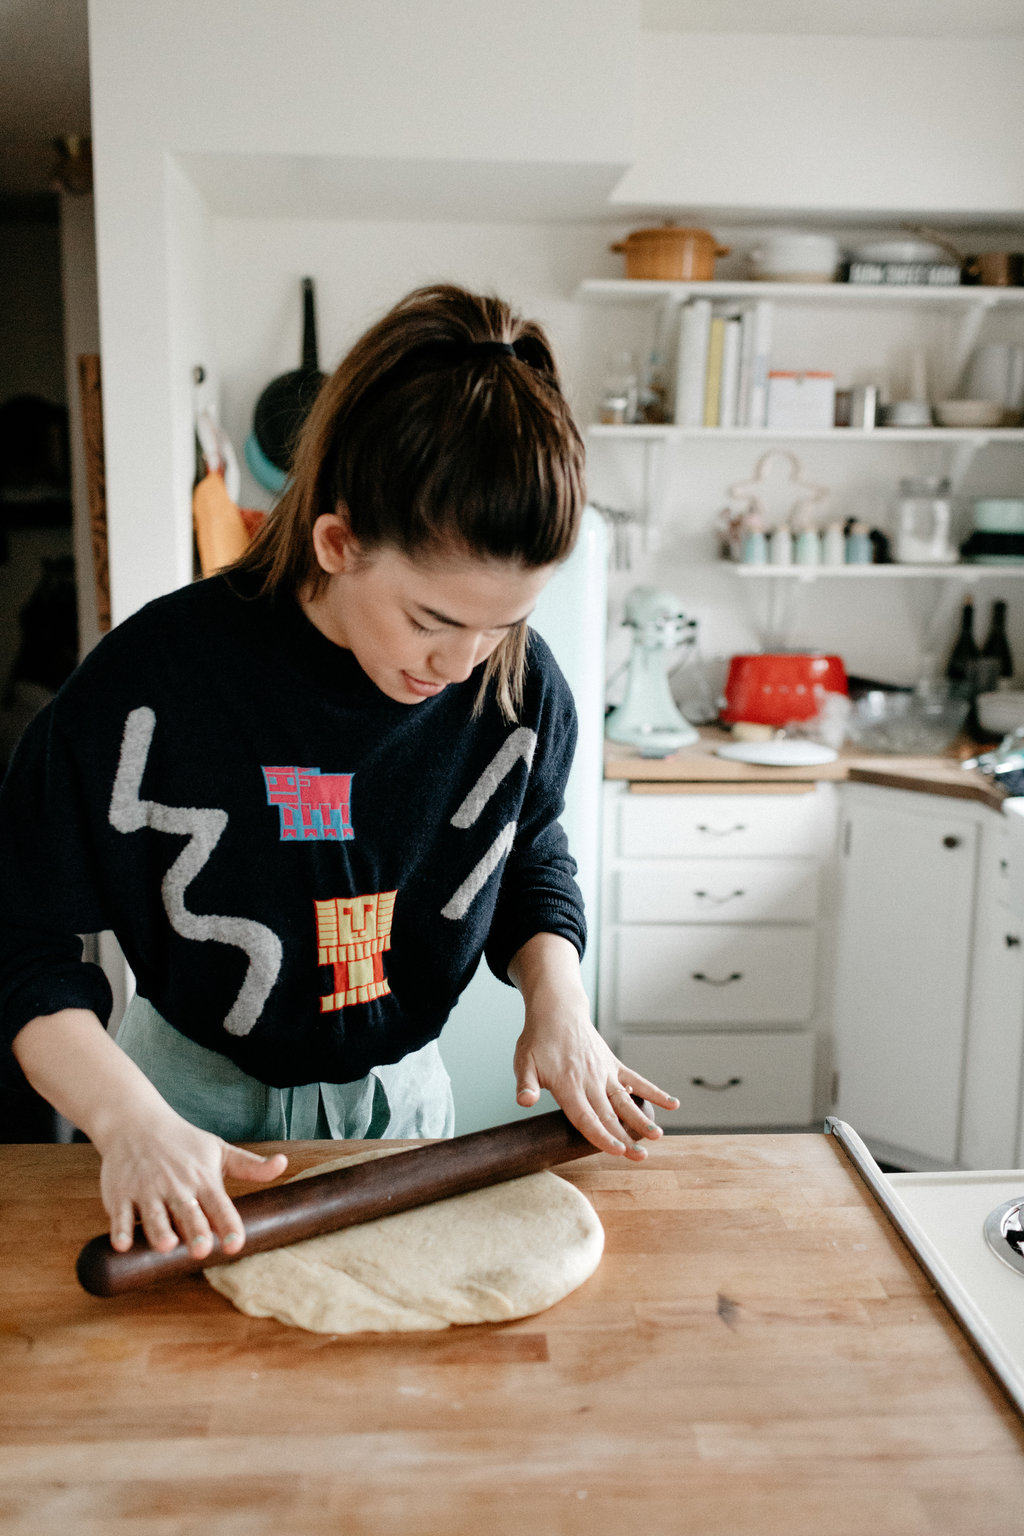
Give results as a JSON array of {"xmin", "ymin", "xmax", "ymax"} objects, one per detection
[{"xmin": 89, "ymin": 0, "xmax": 636, "ymax": 621}]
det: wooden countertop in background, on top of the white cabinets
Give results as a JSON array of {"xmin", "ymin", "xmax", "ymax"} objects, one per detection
[{"xmin": 605, "ymin": 727, "xmax": 1006, "ymax": 809}]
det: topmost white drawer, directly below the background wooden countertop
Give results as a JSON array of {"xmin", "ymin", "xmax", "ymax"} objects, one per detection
[{"xmin": 619, "ymin": 794, "xmax": 824, "ymax": 859}]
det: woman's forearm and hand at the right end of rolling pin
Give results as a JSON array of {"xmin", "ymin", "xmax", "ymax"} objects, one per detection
[{"xmin": 508, "ymin": 934, "xmax": 679, "ymax": 1161}]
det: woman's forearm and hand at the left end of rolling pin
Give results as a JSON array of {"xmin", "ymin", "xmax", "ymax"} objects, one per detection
[{"xmin": 14, "ymin": 1008, "xmax": 287, "ymax": 1258}]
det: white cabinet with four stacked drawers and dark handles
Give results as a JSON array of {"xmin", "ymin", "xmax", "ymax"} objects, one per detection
[{"xmin": 599, "ymin": 783, "xmax": 835, "ymax": 1129}]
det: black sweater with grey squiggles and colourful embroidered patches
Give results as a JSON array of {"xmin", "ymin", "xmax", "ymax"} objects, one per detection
[{"xmin": 0, "ymin": 576, "xmax": 585, "ymax": 1087}]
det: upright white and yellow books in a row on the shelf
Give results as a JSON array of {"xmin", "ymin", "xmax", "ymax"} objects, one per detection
[{"xmin": 674, "ymin": 298, "xmax": 772, "ymax": 427}]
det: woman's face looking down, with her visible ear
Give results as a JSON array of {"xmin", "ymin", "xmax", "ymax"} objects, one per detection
[{"xmin": 301, "ymin": 513, "xmax": 554, "ymax": 703}]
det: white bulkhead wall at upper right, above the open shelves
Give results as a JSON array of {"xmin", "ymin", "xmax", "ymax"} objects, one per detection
[{"xmin": 614, "ymin": 32, "xmax": 1024, "ymax": 218}]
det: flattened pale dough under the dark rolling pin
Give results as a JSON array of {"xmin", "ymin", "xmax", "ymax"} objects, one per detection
[{"xmin": 206, "ymin": 1147, "xmax": 605, "ymax": 1333}]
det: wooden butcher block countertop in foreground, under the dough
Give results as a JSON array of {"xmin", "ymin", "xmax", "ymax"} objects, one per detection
[{"xmin": 0, "ymin": 1134, "xmax": 1024, "ymax": 1536}]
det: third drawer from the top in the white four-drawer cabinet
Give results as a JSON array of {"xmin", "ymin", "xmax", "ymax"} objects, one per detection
[{"xmin": 616, "ymin": 923, "xmax": 815, "ymax": 1026}]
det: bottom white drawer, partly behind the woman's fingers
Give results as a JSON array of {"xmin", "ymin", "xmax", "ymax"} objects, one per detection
[{"xmin": 619, "ymin": 1034, "xmax": 814, "ymax": 1130}]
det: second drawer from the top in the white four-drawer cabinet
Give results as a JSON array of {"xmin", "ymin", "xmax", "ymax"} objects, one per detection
[{"xmin": 617, "ymin": 859, "xmax": 818, "ymax": 923}]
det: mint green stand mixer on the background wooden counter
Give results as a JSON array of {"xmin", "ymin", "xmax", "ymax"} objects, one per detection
[{"xmin": 605, "ymin": 587, "xmax": 700, "ymax": 757}]
